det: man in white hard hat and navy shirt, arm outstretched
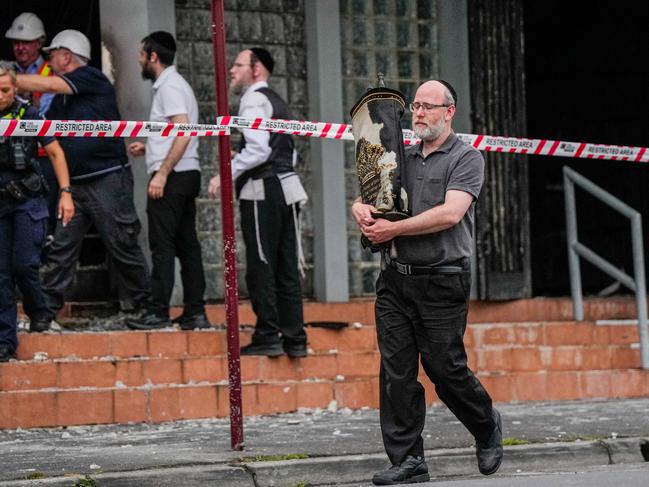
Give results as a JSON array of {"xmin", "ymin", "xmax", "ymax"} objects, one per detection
[{"xmin": 18, "ymin": 29, "xmax": 150, "ymax": 328}]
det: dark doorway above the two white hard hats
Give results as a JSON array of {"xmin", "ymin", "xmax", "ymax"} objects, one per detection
[{"xmin": 0, "ymin": 0, "xmax": 101, "ymax": 69}]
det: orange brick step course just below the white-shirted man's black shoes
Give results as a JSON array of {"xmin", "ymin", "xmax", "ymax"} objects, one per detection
[{"xmin": 12, "ymin": 322, "xmax": 639, "ymax": 365}]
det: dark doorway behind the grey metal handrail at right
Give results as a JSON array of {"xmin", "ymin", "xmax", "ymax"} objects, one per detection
[{"xmin": 524, "ymin": 0, "xmax": 649, "ymax": 296}]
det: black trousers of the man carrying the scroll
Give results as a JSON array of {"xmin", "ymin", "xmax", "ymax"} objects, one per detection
[{"xmin": 376, "ymin": 267, "xmax": 495, "ymax": 465}]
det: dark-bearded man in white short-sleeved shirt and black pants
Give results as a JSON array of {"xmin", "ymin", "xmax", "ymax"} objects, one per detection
[{"xmin": 126, "ymin": 31, "xmax": 210, "ymax": 330}]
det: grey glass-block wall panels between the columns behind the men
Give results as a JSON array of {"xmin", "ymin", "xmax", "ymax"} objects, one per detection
[{"xmin": 175, "ymin": 0, "xmax": 439, "ymax": 299}]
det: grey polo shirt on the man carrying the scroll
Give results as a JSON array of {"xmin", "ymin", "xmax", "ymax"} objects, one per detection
[{"xmin": 395, "ymin": 133, "xmax": 484, "ymax": 265}]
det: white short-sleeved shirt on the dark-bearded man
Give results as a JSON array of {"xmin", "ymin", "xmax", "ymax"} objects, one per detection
[{"xmin": 145, "ymin": 66, "xmax": 200, "ymax": 174}]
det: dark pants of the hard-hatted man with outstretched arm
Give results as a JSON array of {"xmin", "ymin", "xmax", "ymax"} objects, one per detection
[{"xmin": 41, "ymin": 168, "xmax": 150, "ymax": 318}]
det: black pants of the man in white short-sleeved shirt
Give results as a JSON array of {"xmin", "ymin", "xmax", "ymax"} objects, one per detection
[{"xmin": 147, "ymin": 171, "xmax": 205, "ymax": 316}]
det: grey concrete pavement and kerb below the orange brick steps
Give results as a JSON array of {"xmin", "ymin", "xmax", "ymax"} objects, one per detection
[{"xmin": 0, "ymin": 398, "xmax": 649, "ymax": 487}]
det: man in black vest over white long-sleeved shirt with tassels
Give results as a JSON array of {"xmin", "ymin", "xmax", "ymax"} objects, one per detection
[{"xmin": 208, "ymin": 47, "xmax": 307, "ymax": 358}]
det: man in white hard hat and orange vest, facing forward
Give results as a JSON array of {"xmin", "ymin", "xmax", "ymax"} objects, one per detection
[{"xmin": 5, "ymin": 12, "xmax": 54, "ymax": 115}]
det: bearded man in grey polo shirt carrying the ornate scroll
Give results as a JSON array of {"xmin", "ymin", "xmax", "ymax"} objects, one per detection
[{"xmin": 352, "ymin": 80, "xmax": 503, "ymax": 485}]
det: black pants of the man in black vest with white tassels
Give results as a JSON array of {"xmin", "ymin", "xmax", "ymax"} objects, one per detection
[{"xmin": 240, "ymin": 177, "xmax": 306, "ymax": 344}]
